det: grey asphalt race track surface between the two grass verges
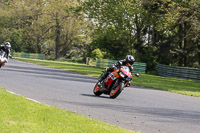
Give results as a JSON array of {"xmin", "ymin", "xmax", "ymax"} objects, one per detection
[{"xmin": 0, "ymin": 60, "xmax": 200, "ymax": 133}]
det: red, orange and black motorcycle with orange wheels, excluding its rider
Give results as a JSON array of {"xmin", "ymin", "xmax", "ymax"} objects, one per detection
[{"xmin": 93, "ymin": 66, "xmax": 139, "ymax": 99}]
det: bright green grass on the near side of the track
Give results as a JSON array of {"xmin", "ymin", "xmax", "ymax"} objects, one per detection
[{"xmin": 0, "ymin": 88, "xmax": 135, "ymax": 133}]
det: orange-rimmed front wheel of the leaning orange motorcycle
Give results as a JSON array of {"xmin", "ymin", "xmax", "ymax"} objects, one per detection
[{"xmin": 110, "ymin": 82, "xmax": 124, "ymax": 98}]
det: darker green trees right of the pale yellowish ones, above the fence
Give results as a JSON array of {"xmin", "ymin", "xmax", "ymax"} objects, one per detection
[{"xmin": 82, "ymin": 0, "xmax": 200, "ymax": 69}]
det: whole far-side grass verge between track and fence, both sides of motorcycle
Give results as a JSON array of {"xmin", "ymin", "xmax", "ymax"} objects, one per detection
[{"xmin": 14, "ymin": 58, "xmax": 200, "ymax": 97}]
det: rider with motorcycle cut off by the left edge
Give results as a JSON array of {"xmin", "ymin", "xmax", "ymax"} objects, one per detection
[{"xmin": 0, "ymin": 42, "xmax": 11, "ymax": 65}]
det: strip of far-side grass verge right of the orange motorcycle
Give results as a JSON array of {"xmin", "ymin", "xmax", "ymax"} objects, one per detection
[{"xmin": 133, "ymin": 74, "xmax": 200, "ymax": 97}]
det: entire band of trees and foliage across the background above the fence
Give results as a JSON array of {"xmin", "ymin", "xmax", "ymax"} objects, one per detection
[{"xmin": 0, "ymin": 0, "xmax": 200, "ymax": 70}]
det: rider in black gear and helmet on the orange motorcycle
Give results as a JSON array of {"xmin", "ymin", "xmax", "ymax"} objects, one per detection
[{"xmin": 98, "ymin": 55, "xmax": 135, "ymax": 84}]
